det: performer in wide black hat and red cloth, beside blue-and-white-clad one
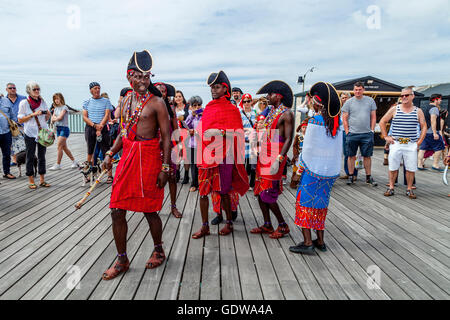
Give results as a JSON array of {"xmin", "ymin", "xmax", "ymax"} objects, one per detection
[{"xmin": 250, "ymin": 80, "xmax": 294, "ymax": 239}]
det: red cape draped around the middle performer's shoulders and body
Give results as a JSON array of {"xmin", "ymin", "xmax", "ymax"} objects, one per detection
[{"xmin": 197, "ymin": 97, "xmax": 249, "ymax": 196}]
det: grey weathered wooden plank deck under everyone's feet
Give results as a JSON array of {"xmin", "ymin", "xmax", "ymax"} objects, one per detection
[{"xmin": 0, "ymin": 134, "xmax": 450, "ymax": 300}]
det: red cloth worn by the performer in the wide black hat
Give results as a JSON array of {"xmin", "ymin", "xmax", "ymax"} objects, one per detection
[{"xmin": 256, "ymin": 113, "xmax": 287, "ymax": 181}]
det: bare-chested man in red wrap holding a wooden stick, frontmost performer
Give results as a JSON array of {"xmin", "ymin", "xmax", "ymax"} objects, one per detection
[{"xmin": 102, "ymin": 50, "xmax": 170, "ymax": 280}]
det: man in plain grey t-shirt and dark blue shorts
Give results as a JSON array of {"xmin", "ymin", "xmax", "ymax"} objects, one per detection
[{"xmin": 342, "ymin": 81, "xmax": 377, "ymax": 187}]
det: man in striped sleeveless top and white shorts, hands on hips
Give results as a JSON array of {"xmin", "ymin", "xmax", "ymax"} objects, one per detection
[{"xmin": 380, "ymin": 87, "xmax": 427, "ymax": 199}]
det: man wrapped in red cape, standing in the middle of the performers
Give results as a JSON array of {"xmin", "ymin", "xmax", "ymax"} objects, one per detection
[{"xmin": 192, "ymin": 71, "xmax": 249, "ymax": 239}]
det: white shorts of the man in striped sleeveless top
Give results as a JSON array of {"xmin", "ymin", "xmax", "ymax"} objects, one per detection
[{"xmin": 389, "ymin": 141, "xmax": 417, "ymax": 172}]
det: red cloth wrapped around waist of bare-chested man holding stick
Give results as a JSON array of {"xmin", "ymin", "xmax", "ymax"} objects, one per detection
[{"xmin": 109, "ymin": 131, "xmax": 164, "ymax": 213}]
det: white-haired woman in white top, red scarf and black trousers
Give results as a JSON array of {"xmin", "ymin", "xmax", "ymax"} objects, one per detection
[{"xmin": 17, "ymin": 81, "xmax": 51, "ymax": 190}]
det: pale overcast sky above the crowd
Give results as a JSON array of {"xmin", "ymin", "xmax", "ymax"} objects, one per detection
[{"xmin": 0, "ymin": 0, "xmax": 450, "ymax": 108}]
